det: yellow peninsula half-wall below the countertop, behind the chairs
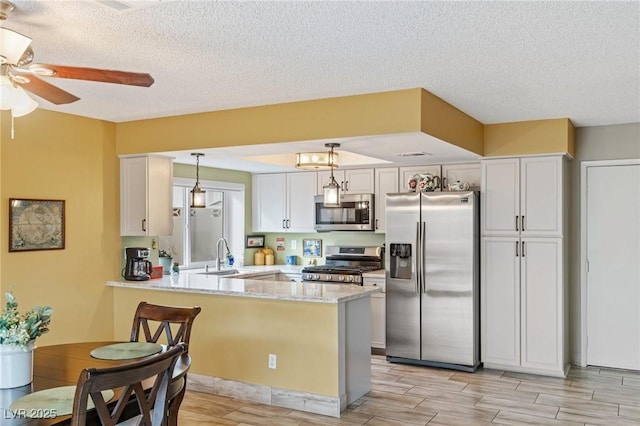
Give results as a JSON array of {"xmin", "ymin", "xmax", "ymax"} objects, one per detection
[{"xmin": 114, "ymin": 288, "xmax": 339, "ymax": 397}]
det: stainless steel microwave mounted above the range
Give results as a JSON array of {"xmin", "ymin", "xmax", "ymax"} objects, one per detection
[{"xmin": 314, "ymin": 194, "xmax": 375, "ymax": 232}]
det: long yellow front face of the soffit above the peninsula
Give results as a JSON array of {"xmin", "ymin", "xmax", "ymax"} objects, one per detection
[{"xmin": 117, "ymin": 89, "xmax": 422, "ymax": 154}]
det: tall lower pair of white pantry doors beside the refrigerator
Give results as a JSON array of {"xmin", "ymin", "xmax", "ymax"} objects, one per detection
[{"xmin": 480, "ymin": 237, "xmax": 568, "ymax": 377}]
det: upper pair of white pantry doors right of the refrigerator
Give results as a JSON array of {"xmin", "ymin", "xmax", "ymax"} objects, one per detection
[{"xmin": 482, "ymin": 156, "xmax": 563, "ymax": 237}]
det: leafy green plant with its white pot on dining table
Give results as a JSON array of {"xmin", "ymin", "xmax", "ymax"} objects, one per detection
[{"xmin": 0, "ymin": 293, "xmax": 53, "ymax": 389}]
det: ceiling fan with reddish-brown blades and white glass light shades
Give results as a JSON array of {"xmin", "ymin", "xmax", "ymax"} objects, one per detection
[{"xmin": 0, "ymin": 0, "xmax": 154, "ymax": 105}]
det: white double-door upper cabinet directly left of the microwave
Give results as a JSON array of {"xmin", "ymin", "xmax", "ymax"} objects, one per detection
[{"xmin": 252, "ymin": 172, "xmax": 316, "ymax": 232}]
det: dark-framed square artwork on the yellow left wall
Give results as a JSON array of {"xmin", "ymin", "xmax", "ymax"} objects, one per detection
[{"xmin": 9, "ymin": 198, "xmax": 64, "ymax": 252}]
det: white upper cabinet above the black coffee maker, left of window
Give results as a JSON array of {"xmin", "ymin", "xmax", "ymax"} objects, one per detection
[{"xmin": 120, "ymin": 155, "xmax": 173, "ymax": 236}]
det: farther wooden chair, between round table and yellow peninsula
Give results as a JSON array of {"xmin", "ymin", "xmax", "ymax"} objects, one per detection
[{"xmin": 130, "ymin": 302, "xmax": 201, "ymax": 426}]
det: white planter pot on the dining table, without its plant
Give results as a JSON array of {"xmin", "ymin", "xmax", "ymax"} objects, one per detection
[{"xmin": 0, "ymin": 341, "xmax": 36, "ymax": 389}]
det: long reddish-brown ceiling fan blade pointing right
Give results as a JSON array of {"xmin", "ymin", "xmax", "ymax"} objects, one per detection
[{"xmin": 29, "ymin": 64, "xmax": 154, "ymax": 87}]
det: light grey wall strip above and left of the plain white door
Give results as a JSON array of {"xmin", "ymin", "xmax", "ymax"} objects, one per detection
[{"xmin": 569, "ymin": 123, "xmax": 640, "ymax": 365}]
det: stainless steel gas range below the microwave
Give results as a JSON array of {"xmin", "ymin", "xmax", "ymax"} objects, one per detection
[{"xmin": 302, "ymin": 246, "xmax": 382, "ymax": 285}]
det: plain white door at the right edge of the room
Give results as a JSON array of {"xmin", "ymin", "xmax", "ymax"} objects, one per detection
[{"xmin": 583, "ymin": 164, "xmax": 640, "ymax": 370}]
